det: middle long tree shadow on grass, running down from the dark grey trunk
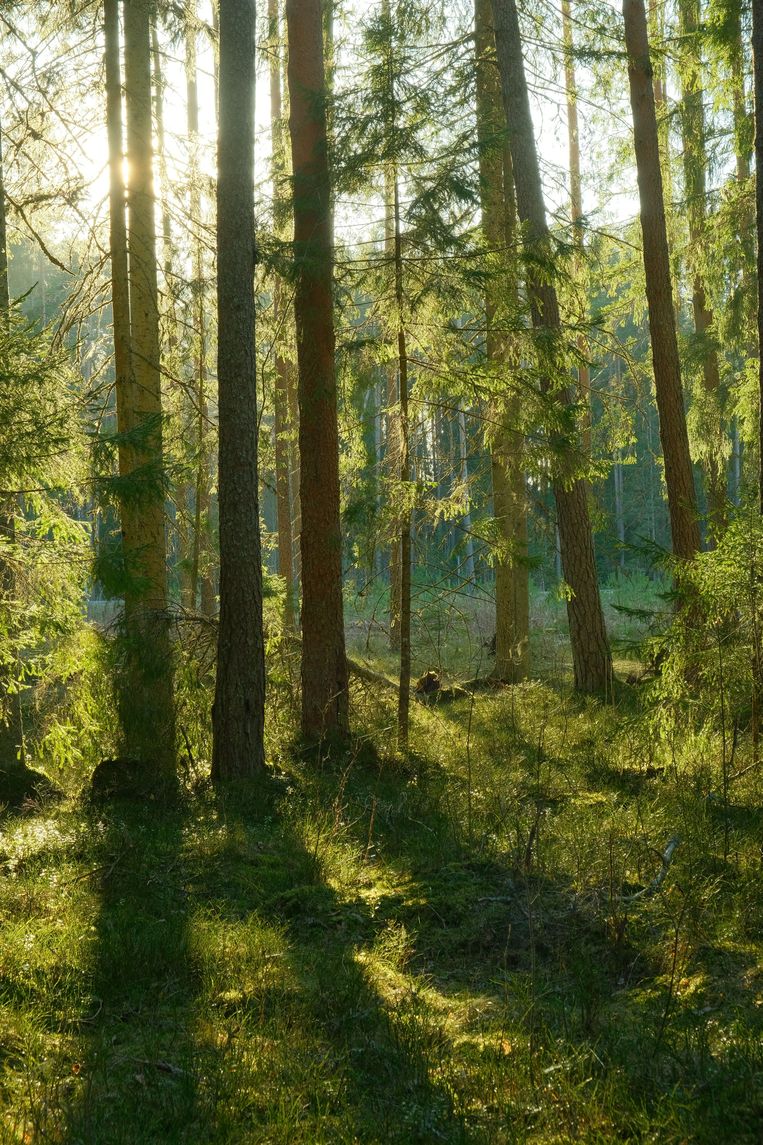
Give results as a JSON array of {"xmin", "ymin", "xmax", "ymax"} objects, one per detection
[{"xmin": 184, "ymin": 783, "xmax": 472, "ymax": 1143}]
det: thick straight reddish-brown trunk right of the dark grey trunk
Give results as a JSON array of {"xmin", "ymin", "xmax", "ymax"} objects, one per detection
[{"xmin": 281, "ymin": 0, "xmax": 349, "ymax": 739}]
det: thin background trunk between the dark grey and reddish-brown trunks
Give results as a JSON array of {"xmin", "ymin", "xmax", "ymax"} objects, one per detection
[{"xmin": 268, "ymin": 0, "xmax": 297, "ymax": 629}]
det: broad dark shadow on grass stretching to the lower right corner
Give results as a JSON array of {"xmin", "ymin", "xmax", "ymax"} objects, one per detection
[{"xmin": 288, "ymin": 751, "xmax": 762, "ymax": 1145}]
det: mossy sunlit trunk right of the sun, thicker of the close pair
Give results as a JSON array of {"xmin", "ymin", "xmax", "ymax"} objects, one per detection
[{"xmin": 112, "ymin": 0, "xmax": 175, "ymax": 782}]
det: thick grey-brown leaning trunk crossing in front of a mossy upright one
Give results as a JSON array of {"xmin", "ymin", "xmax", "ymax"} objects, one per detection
[{"xmin": 493, "ymin": 0, "xmax": 612, "ymax": 692}]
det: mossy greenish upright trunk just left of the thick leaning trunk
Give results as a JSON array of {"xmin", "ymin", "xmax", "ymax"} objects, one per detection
[{"xmin": 474, "ymin": 0, "xmax": 529, "ymax": 682}]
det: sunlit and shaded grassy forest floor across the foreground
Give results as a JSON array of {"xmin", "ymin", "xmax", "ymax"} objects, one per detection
[{"xmin": 0, "ymin": 684, "xmax": 763, "ymax": 1145}]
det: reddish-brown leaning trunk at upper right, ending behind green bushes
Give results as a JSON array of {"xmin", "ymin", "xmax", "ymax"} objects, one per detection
[{"xmin": 623, "ymin": 0, "xmax": 700, "ymax": 560}]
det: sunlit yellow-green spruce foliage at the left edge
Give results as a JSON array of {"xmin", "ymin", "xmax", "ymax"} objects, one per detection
[{"xmin": 0, "ymin": 310, "xmax": 88, "ymax": 764}]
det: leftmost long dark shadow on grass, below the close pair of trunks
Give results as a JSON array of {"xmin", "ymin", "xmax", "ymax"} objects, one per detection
[{"xmin": 56, "ymin": 802, "xmax": 201, "ymax": 1145}]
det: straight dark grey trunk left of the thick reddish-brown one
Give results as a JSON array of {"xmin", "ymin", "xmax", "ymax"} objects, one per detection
[{"xmin": 212, "ymin": 0, "xmax": 265, "ymax": 781}]
